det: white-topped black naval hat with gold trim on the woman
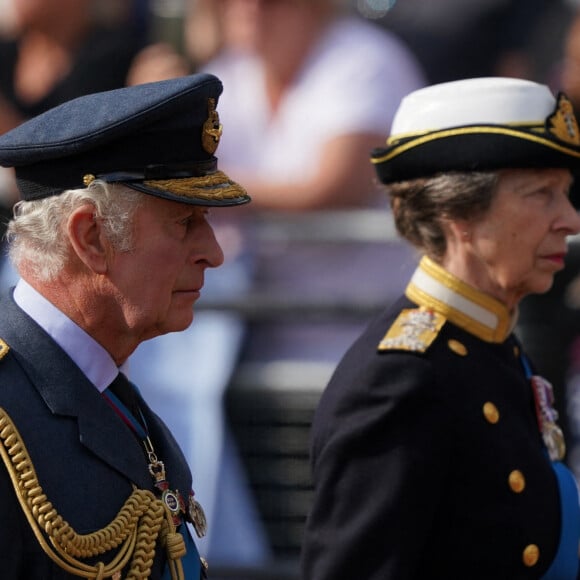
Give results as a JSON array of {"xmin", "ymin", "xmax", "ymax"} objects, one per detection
[{"xmin": 371, "ymin": 77, "xmax": 580, "ymax": 183}]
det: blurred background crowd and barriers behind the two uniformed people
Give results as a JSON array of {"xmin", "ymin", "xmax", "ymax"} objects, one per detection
[{"xmin": 0, "ymin": 0, "xmax": 580, "ymax": 567}]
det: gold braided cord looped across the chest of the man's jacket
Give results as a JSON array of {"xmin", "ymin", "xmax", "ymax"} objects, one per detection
[{"xmin": 0, "ymin": 408, "xmax": 186, "ymax": 580}]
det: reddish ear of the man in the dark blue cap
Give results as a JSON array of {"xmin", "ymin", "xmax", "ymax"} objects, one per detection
[{"xmin": 67, "ymin": 204, "xmax": 108, "ymax": 274}]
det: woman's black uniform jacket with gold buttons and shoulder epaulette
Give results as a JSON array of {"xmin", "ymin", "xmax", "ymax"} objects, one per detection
[{"xmin": 302, "ymin": 261, "xmax": 577, "ymax": 580}]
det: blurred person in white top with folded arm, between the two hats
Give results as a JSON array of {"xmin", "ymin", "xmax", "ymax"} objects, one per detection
[{"xmin": 196, "ymin": 0, "xmax": 424, "ymax": 210}]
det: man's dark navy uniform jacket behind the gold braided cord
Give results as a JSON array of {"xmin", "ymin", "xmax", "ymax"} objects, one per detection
[{"xmin": 0, "ymin": 297, "xmax": 196, "ymax": 580}]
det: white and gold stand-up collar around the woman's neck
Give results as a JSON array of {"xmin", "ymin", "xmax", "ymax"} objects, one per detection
[{"xmin": 405, "ymin": 256, "xmax": 516, "ymax": 343}]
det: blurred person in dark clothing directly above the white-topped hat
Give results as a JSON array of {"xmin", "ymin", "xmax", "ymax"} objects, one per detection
[{"xmin": 372, "ymin": 0, "xmax": 549, "ymax": 84}]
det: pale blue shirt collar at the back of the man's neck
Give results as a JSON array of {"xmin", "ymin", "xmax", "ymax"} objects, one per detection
[{"xmin": 14, "ymin": 279, "xmax": 119, "ymax": 393}]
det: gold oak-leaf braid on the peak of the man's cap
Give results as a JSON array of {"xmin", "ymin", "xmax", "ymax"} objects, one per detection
[{"xmin": 143, "ymin": 171, "xmax": 246, "ymax": 200}]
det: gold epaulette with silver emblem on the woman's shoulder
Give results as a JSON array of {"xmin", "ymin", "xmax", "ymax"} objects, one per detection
[{"xmin": 378, "ymin": 307, "xmax": 446, "ymax": 352}]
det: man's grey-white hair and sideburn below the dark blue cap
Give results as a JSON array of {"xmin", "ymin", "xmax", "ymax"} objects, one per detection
[{"xmin": 6, "ymin": 180, "xmax": 145, "ymax": 281}]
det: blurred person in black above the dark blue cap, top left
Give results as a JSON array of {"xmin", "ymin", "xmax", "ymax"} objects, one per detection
[{"xmin": 0, "ymin": 0, "xmax": 145, "ymax": 133}]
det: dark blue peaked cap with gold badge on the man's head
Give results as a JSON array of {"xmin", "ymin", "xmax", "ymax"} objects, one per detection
[{"xmin": 0, "ymin": 74, "xmax": 250, "ymax": 206}]
